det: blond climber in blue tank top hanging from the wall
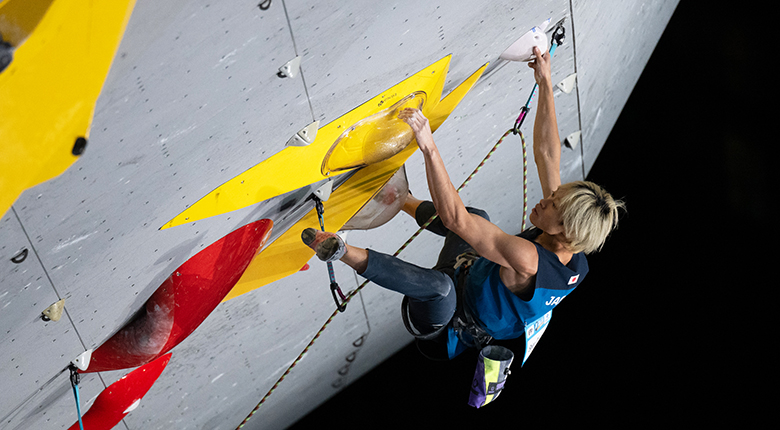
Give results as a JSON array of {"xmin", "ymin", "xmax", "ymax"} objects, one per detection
[{"xmin": 301, "ymin": 48, "xmax": 623, "ymax": 358}]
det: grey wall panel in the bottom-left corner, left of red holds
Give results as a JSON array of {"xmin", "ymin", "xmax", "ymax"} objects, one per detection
[{"xmin": 0, "ymin": 210, "xmax": 96, "ymax": 428}]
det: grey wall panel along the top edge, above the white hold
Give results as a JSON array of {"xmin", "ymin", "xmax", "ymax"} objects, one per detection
[{"xmin": 288, "ymin": 0, "xmax": 568, "ymax": 122}]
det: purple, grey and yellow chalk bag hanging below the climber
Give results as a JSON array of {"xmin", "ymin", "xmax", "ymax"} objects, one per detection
[{"xmin": 469, "ymin": 345, "xmax": 515, "ymax": 408}]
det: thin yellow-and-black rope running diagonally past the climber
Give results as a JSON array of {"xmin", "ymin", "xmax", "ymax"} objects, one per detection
[{"xmin": 237, "ymin": 128, "xmax": 528, "ymax": 429}]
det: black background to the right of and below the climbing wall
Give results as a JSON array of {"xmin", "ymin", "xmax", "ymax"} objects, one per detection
[{"xmin": 295, "ymin": 1, "xmax": 777, "ymax": 429}]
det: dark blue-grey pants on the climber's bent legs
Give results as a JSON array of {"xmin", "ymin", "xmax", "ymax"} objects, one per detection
[{"xmin": 360, "ymin": 202, "xmax": 490, "ymax": 334}]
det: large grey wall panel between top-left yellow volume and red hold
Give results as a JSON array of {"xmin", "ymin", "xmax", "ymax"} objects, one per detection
[{"xmin": 10, "ymin": 2, "xmax": 310, "ymax": 346}]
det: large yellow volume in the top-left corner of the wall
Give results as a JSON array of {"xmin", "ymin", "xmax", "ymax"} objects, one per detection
[{"xmin": 0, "ymin": 0, "xmax": 135, "ymax": 215}]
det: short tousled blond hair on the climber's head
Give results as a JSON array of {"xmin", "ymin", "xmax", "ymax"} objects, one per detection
[{"xmin": 556, "ymin": 181, "xmax": 625, "ymax": 254}]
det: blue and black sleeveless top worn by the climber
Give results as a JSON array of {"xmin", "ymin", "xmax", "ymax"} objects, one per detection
[{"xmin": 447, "ymin": 229, "xmax": 588, "ymax": 359}]
